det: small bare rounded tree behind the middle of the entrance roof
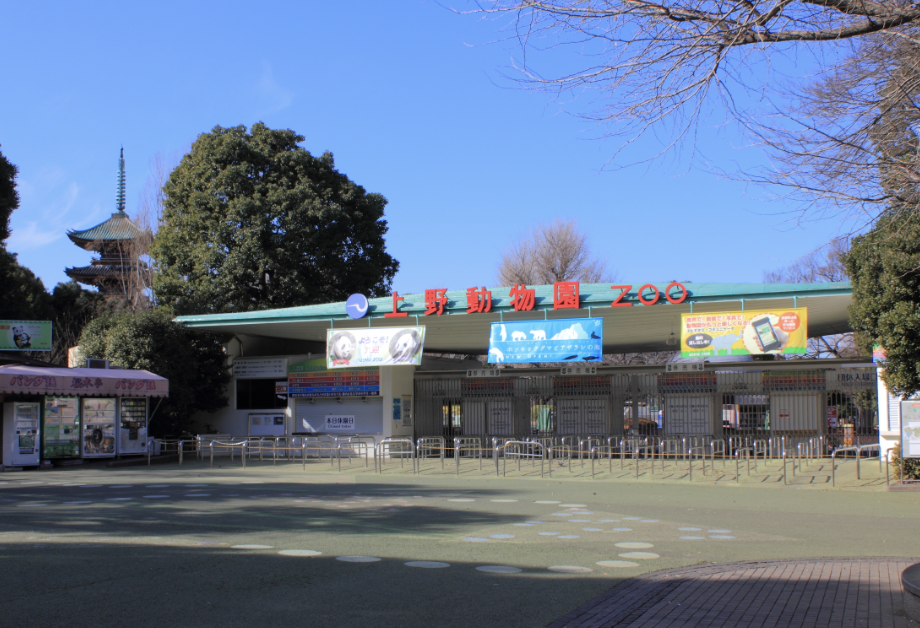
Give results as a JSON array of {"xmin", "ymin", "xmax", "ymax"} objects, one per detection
[{"xmin": 498, "ymin": 219, "xmax": 613, "ymax": 286}]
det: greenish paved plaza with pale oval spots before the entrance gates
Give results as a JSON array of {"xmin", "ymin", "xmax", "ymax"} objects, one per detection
[{"xmin": 0, "ymin": 461, "xmax": 920, "ymax": 628}]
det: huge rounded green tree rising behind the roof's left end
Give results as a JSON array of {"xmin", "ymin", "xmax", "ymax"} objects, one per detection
[{"xmin": 150, "ymin": 123, "xmax": 399, "ymax": 314}]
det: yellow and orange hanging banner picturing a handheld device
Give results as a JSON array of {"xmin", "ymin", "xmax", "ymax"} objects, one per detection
[{"xmin": 680, "ymin": 307, "xmax": 808, "ymax": 358}]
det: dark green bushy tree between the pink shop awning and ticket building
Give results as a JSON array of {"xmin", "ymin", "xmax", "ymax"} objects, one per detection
[{"xmin": 80, "ymin": 309, "xmax": 230, "ymax": 436}]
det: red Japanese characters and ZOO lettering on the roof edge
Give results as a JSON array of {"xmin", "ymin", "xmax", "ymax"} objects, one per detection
[{"xmin": 384, "ymin": 281, "xmax": 688, "ymax": 318}]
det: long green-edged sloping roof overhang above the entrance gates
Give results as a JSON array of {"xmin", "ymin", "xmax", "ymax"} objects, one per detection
[{"xmin": 176, "ymin": 282, "xmax": 852, "ymax": 355}]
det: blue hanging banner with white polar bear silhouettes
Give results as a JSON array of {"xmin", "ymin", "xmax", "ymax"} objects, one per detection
[{"xmin": 489, "ymin": 318, "xmax": 604, "ymax": 364}]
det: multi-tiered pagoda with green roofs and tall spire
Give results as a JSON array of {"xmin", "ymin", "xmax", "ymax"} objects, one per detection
[{"xmin": 64, "ymin": 148, "xmax": 153, "ymax": 295}]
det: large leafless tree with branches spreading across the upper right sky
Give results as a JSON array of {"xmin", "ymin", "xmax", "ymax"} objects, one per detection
[{"xmin": 464, "ymin": 0, "xmax": 920, "ymax": 228}]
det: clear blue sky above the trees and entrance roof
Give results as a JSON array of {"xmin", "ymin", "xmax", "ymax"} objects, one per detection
[{"xmin": 0, "ymin": 0, "xmax": 852, "ymax": 293}]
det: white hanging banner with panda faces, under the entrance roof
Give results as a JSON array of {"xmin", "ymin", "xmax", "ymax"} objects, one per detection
[{"xmin": 326, "ymin": 326, "xmax": 425, "ymax": 369}]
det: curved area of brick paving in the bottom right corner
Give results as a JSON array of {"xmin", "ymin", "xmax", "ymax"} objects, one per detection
[{"xmin": 547, "ymin": 558, "xmax": 920, "ymax": 628}]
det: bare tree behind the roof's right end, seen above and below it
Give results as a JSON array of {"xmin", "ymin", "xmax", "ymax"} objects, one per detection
[{"xmin": 763, "ymin": 238, "xmax": 859, "ymax": 359}]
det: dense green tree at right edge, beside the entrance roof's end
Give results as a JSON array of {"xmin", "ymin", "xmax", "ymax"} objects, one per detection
[{"xmin": 845, "ymin": 211, "xmax": 920, "ymax": 395}]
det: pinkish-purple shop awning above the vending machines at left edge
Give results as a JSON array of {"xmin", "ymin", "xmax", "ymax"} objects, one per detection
[{"xmin": 0, "ymin": 366, "xmax": 169, "ymax": 397}]
